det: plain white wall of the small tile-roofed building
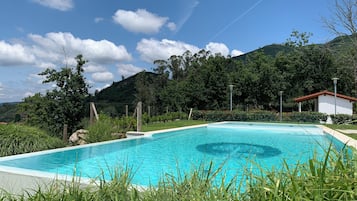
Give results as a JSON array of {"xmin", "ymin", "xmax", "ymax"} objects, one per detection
[{"xmin": 318, "ymin": 95, "xmax": 353, "ymax": 115}]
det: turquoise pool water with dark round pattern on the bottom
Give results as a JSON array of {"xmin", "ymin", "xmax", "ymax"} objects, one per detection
[{"xmin": 0, "ymin": 122, "xmax": 337, "ymax": 186}]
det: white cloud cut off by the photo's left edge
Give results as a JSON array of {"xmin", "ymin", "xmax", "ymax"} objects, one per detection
[{"xmin": 0, "ymin": 41, "xmax": 35, "ymax": 66}]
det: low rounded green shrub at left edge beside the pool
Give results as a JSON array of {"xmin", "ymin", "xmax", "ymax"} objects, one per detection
[{"xmin": 0, "ymin": 124, "xmax": 64, "ymax": 156}]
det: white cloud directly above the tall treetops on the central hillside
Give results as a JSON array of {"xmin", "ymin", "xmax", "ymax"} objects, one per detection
[{"xmin": 136, "ymin": 39, "xmax": 200, "ymax": 63}]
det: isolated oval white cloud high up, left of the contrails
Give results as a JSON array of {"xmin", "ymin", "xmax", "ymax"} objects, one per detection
[{"xmin": 113, "ymin": 9, "xmax": 168, "ymax": 34}]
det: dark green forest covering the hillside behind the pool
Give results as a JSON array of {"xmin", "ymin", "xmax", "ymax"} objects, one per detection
[{"xmin": 93, "ymin": 34, "xmax": 356, "ymax": 116}]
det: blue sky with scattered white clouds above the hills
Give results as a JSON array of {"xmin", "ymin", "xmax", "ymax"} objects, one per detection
[{"xmin": 0, "ymin": 0, "xmax": 335, "ymax": 103}]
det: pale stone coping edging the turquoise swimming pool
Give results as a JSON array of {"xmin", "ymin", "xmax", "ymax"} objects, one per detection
[{"xmin": 0, "ymin": 121, "xmax": 357, "ymax": 195}]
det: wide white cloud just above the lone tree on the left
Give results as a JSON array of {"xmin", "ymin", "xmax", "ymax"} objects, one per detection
[{"xmin": 29, "ymin": 32, "xmax": 131, "ymax": 64}]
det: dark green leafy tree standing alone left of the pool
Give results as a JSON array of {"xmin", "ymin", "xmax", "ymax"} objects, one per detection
[{"xmin": 19, "ymin": 55, "xmax": 88, "ymax": 135}]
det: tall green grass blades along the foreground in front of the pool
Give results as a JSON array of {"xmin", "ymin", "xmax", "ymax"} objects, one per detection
[{"xmin": 0, "ymin": 144, "xmax": 357, "ymax": 201}]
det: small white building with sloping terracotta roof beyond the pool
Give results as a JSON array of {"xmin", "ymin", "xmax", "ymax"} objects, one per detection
[{"xmin": 294, "ymin": 90, "xmax": 357, "ymax": 115}]
